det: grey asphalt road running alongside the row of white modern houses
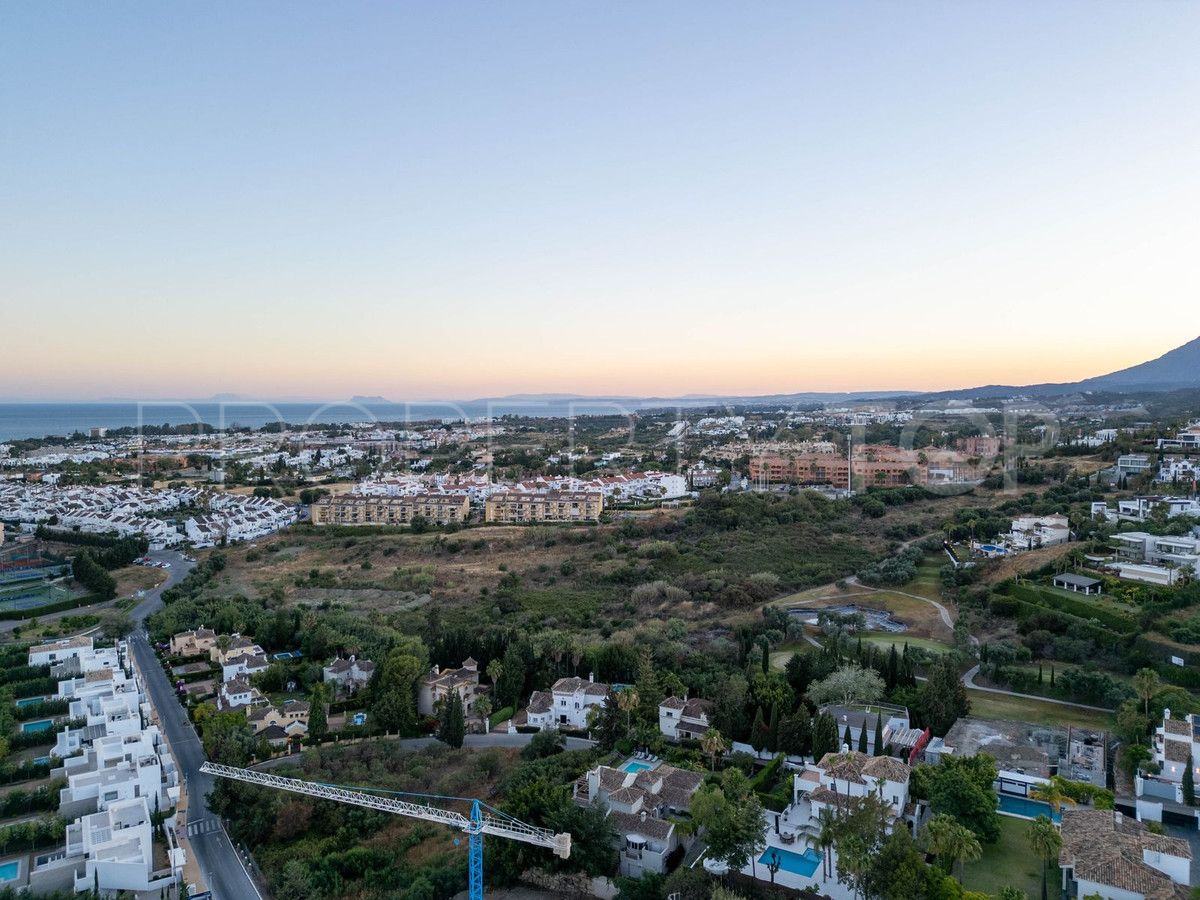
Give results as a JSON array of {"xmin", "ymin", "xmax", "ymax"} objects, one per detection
[{"xmin": 130, "ymin": 551, "xmax": 262, "ymax": 900}]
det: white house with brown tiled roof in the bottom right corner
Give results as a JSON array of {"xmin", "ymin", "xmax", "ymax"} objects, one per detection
[{"xmin": 1058, "ymin": 809, "xmax": 1192, "ymax": 900}]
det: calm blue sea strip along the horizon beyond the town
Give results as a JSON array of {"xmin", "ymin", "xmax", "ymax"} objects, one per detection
[{"xmin": 0, "ymin": 400, "xmax": 681, "ymax": 440}]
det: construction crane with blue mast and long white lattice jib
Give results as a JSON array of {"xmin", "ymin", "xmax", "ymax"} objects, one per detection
[{"xmin": 200, "ymin": 762, "xmax": 571, "ymax": 900}]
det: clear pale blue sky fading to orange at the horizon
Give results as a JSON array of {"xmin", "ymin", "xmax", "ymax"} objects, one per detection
[{"xmin": 0, "ymin": 0, "xmax": 1200, "ymax": 400}]
